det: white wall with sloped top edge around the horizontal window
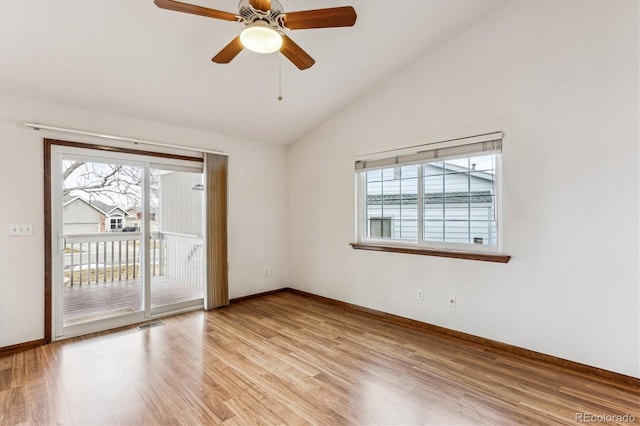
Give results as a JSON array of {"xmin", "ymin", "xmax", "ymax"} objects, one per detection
[{"xmin": 289, "ymin": 0, "xmax": 640, "ymax": 377}]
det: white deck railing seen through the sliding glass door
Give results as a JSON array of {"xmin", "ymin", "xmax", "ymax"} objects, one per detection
[{"xmin": 64, "ymin": 232, "xmax": 204, "ymax": 289}]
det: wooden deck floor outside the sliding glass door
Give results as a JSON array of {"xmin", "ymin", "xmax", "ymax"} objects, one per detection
[{"xmin": 64, "ymin": 276, "xmax": 202, "ymax": 325}]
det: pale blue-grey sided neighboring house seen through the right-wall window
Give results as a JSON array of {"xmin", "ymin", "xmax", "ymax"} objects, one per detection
[{"xmin": 366, "ymin": 162, "xmax": 496, "ymax": 244}]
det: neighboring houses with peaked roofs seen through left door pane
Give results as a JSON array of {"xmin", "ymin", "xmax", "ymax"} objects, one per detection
[{"xmin": 62, "ymin": 196, "xmax": 140, "ymax": 234}]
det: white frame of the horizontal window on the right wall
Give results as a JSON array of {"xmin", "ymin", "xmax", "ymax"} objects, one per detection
[{"xmin": 355, "ymin": 132, "xmax": 503, "ymax": 254}]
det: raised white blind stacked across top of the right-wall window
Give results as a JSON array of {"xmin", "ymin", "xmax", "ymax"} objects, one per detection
[{"xmin": 355, "ymin": 132, "xmax": 502, "ymax": 171}]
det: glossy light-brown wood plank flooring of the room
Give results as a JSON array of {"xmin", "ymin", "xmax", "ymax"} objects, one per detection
[{"xmin": 0, "ymin": 292, "xmax": 640, "ymax": 425}]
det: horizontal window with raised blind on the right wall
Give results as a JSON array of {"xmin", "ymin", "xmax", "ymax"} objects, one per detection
[{"xmin": 356, "ymin": 133, "xmax": 502, "ymax": 252}]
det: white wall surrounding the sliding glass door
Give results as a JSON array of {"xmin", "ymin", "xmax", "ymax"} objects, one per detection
[{"xmin": 0, "ymin": 95, "xmax": 288, "ymax": 347}]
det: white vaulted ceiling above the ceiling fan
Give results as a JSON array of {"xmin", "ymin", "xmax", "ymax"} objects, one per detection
[{"xmin": 0, "ymin": 0, "xmax": 508, "ymax": 144}]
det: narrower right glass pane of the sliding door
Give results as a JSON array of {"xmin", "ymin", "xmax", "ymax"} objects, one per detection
[{"xmin": 149, "ymin": 165, "xmax": 204, "ymax": 313}]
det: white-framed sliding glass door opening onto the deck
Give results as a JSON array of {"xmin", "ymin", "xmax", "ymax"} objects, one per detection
[{"xmin": 51, "ymin": 146, "xmax": 205, "ymax": 339}]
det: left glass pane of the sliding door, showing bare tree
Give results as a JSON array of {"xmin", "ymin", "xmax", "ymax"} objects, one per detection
[{"xmin": 61, "ymin": 155, "xmax": 144, "ymax": 327}]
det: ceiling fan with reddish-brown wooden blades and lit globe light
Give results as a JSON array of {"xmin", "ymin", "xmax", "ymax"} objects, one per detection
[{"xmin": 154, "ymin": 0, "xmax": 357, "ymax": 70}]
